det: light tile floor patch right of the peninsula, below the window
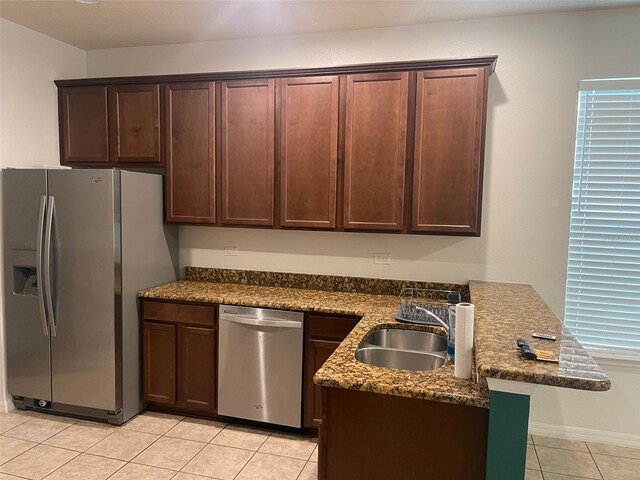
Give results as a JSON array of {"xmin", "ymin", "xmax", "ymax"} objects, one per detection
[{"xmin": 525, "ymin": 435, "xmax": 640, "ymax": 480}]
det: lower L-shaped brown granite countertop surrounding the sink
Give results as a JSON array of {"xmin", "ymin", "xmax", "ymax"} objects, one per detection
[{"xmin": 139, "ymin": 280, "xmax": 488, "ymax": 407}]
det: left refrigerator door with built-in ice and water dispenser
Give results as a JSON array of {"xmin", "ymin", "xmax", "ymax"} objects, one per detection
[{"xmin": 2, "ymin": 170, "xmax": 51, "ymax": 400}]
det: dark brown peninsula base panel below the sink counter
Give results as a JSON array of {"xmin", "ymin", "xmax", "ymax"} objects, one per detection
[{"xmin": 318, "ymin": 388, "xmax": 489, "ymax": 480}]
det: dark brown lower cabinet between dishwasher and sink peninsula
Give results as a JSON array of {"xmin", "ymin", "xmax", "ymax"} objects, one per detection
[{"xmin": 303, "ymin": 313, "xmax": 360, "ymax": 428}]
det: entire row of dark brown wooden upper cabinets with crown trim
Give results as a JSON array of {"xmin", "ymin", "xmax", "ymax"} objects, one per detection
[{"xmin": 55, "ymin": 56, "xmax": 497, "ymax": 236}]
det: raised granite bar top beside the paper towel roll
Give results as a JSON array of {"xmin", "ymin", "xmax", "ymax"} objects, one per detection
[{"xmin": 469, "ymin": 281, "xmax": 611, "ymax": 391}]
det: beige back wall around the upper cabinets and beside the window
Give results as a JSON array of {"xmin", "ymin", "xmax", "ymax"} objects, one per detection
[{"xmin": 87, "ymin": 8, "xmax": 640, "ymax": 441}]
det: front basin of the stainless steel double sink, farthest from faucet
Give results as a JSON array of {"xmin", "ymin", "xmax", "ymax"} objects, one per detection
[{"xmin": 356, "ymin": 347, "xmax": 445, "ymax": 371}]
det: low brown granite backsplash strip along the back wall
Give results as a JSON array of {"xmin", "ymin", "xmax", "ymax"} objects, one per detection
[{"xmin": 185, "ymin": 267, "xmax": 469, "ymax": 300}]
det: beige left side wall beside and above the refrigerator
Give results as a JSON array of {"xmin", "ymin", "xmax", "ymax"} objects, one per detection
[{"xmin": 0, "ymin": 19, "xmax": 87, "ymax": 411}]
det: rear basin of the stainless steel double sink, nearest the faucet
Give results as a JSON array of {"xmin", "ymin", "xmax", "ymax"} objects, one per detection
[{"xmin": 360, "ymin": 328, "xmax": 447, "ymax": 357}]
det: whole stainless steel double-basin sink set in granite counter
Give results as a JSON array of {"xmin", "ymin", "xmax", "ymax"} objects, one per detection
[{"xmin": 356, "ymin": 328, "xmax": 447, "ymax": 371}]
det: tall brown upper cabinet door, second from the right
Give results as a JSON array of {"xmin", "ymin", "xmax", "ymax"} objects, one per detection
[{"xmin": 344, "ymin": 73, "xmax": 409, "ymax": 231}]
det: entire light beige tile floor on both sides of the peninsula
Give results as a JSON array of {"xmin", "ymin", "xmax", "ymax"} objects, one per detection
[{"xmin": 0, "ymin": 412, "xmax": 640, "ymax": 480}]
